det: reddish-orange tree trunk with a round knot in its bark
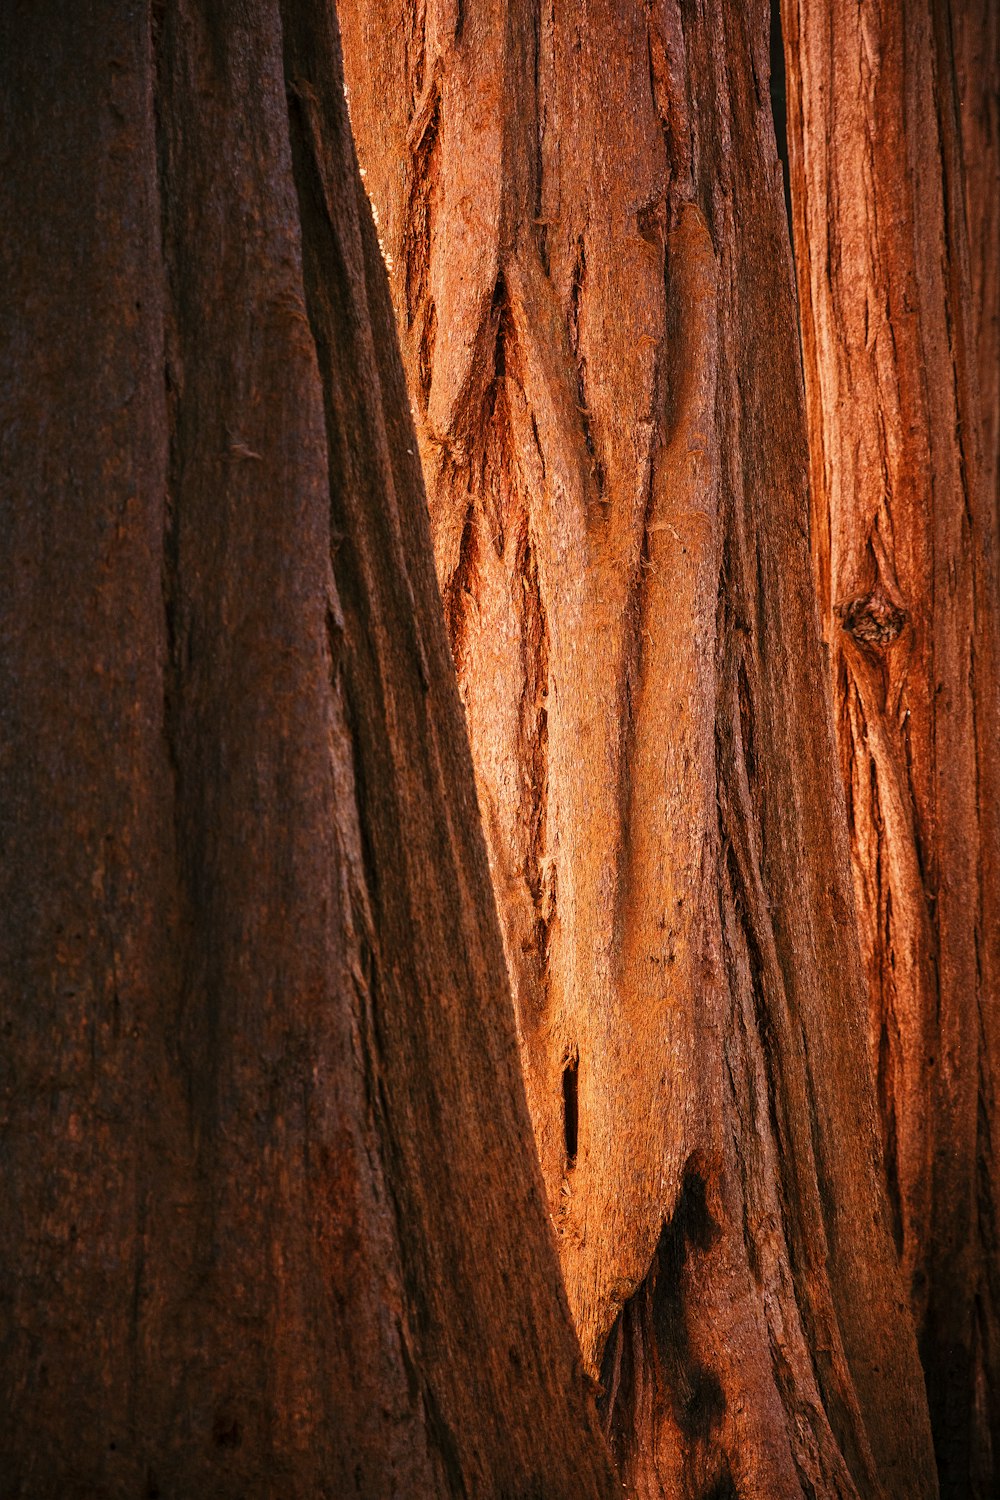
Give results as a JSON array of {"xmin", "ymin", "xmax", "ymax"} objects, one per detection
[{"xmin": 784, "ymin": 0, "xmax": 1000, "ymax": 1496}]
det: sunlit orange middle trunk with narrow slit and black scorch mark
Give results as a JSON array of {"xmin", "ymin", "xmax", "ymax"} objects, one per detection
[{"xmin": 340, "ymin": 0, "xmax": 936, "ymax": 1500}]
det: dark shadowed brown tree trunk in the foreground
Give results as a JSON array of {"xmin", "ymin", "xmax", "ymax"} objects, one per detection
[{"xmin": 0, "ymin": 0, "xmax": 615, "ymax": 1500}]
